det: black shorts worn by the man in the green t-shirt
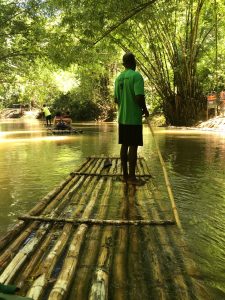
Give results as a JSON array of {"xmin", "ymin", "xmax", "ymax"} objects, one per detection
[{"xmin": 119, "ymin": 124, "xmax": 143, "ymax": 146}]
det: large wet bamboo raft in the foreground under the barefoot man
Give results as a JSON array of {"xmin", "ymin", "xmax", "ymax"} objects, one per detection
[{"xmin": 0, "ymin": 157, "xmax": 211, "ymax": 300}]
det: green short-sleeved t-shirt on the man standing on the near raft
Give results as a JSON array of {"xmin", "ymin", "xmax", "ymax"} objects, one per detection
[{"xmin": 114, "ymin": 69, "xmax": 144, "ymax": 125}]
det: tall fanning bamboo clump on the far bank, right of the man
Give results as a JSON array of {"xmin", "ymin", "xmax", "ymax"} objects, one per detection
[{"xmin": 108, "ymin": 0, "xmax": 221, "ymax": 125}]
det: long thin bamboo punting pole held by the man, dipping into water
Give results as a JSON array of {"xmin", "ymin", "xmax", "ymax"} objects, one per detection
[{"xmin": 146, "ymin": 118, "xmax": 183, "ymax": 231}]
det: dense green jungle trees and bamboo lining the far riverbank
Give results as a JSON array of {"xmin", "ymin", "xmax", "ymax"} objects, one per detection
[{"xmin": 0, "ymin": 0, "xmax": 225, "ymax": 126}]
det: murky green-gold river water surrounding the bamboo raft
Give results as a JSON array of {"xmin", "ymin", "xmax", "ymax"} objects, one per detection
[{"xmin": 0, "ymin": 119, "xmax": 225, "ymax": 299}]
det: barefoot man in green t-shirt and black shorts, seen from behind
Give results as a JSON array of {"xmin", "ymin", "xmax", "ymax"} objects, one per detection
[{"xmin": 114, "ymin": 53, "xmax": 149, "ymax": 185}]
